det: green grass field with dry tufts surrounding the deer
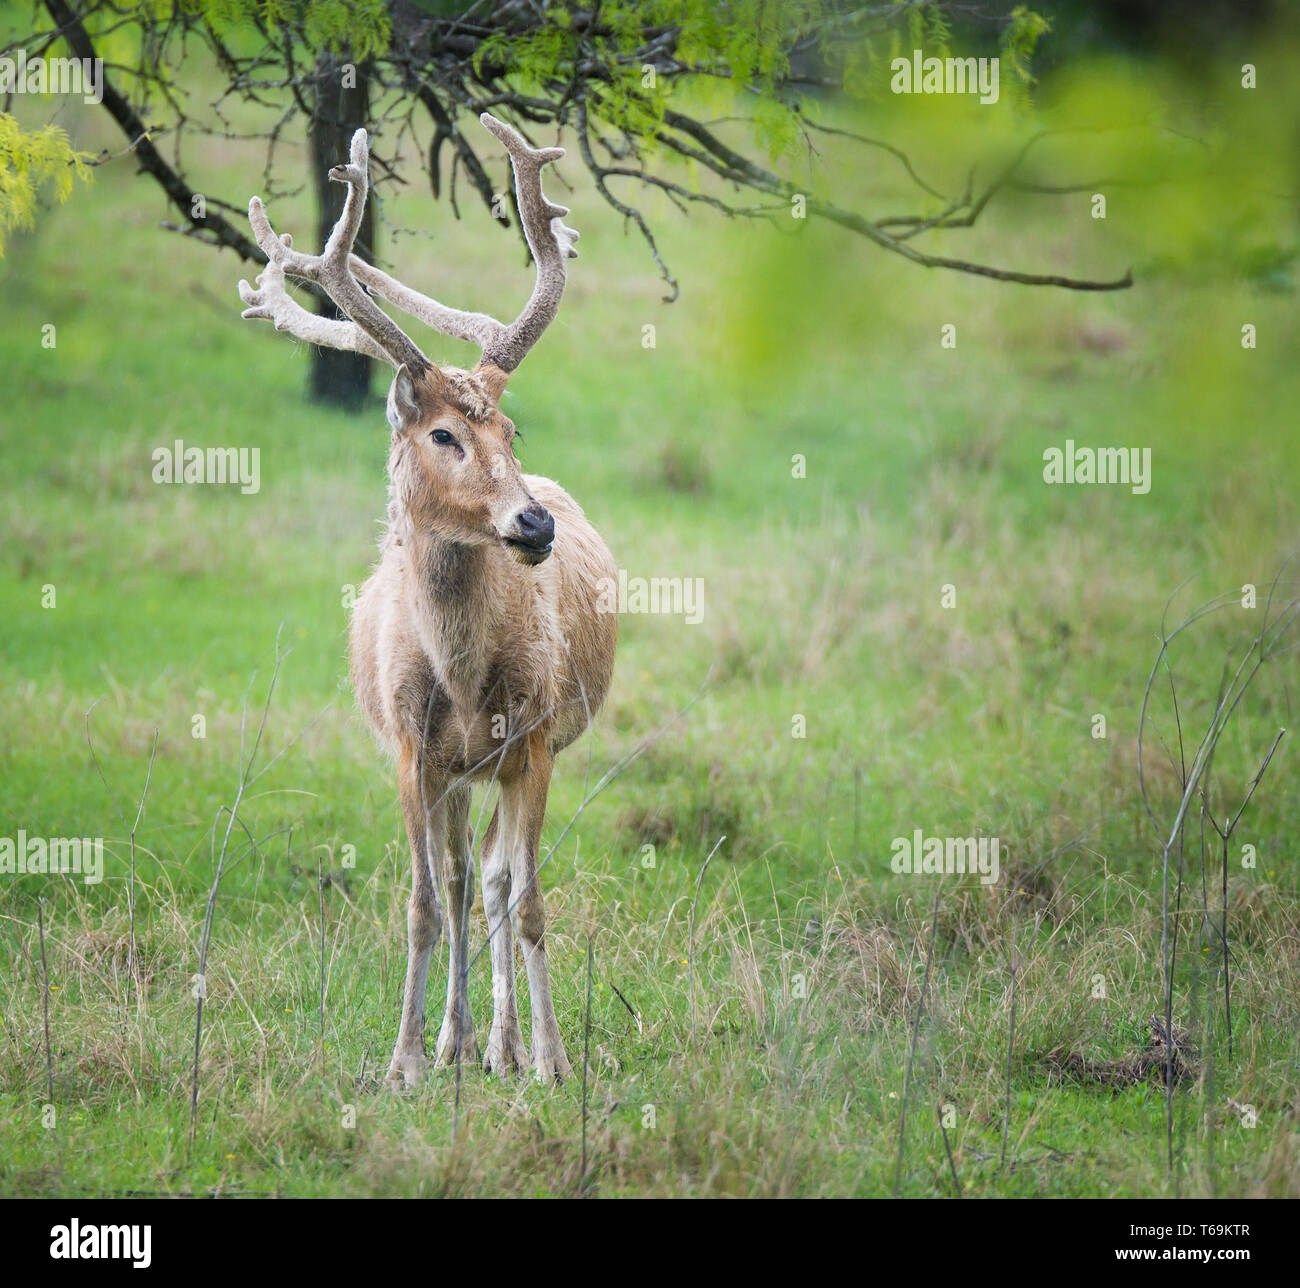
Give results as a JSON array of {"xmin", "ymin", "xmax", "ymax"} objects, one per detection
[{"xmin": 0, "ymin": 42, "xmax": 1300, "ymax": 1197}]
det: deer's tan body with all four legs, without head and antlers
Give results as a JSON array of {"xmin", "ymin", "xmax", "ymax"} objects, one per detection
[{"xmin": 351, "ymin": 441, "xmax": 616, "ymax": 1083}]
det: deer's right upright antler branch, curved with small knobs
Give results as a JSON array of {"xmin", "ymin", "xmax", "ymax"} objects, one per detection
[{"xmin": 478, "ymin": 112, "xmax": 579, "ymax": 372}]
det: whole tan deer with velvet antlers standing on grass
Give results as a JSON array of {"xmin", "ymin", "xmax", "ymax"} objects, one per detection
[{"xmin": 239, "ymin": 113, "xmax": 618, "ymax": 1090}]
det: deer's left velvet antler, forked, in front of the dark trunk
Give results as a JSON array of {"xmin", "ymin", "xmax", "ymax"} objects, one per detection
[{"xmin": 239, "ymin": 130, "xmax": 433, "ymax": 376}]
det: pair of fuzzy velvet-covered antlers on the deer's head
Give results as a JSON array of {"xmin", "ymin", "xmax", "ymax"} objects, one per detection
[{"xmin": 239, "ymin": 112, "xmax": 579, "ymax": 374}]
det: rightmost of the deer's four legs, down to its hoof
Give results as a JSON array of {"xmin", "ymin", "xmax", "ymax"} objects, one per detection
[{"xmin": 502, "ymin": 737, "xmax": 571, "ymax": 1081}]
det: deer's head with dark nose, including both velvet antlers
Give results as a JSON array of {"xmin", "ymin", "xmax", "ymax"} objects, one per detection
[{"xmin": 239, "ymin": 112, "xmax": 577, "ymax": 564}]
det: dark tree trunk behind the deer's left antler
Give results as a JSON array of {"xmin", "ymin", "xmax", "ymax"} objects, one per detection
[{"xmin": 308, "ymin": 53, "xmax": 374, "ymax": 411}]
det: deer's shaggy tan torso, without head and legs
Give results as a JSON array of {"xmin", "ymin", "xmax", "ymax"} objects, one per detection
[{"xmin": 350, "ymin": 462, "xmax": 616, "ymax": 780}]
